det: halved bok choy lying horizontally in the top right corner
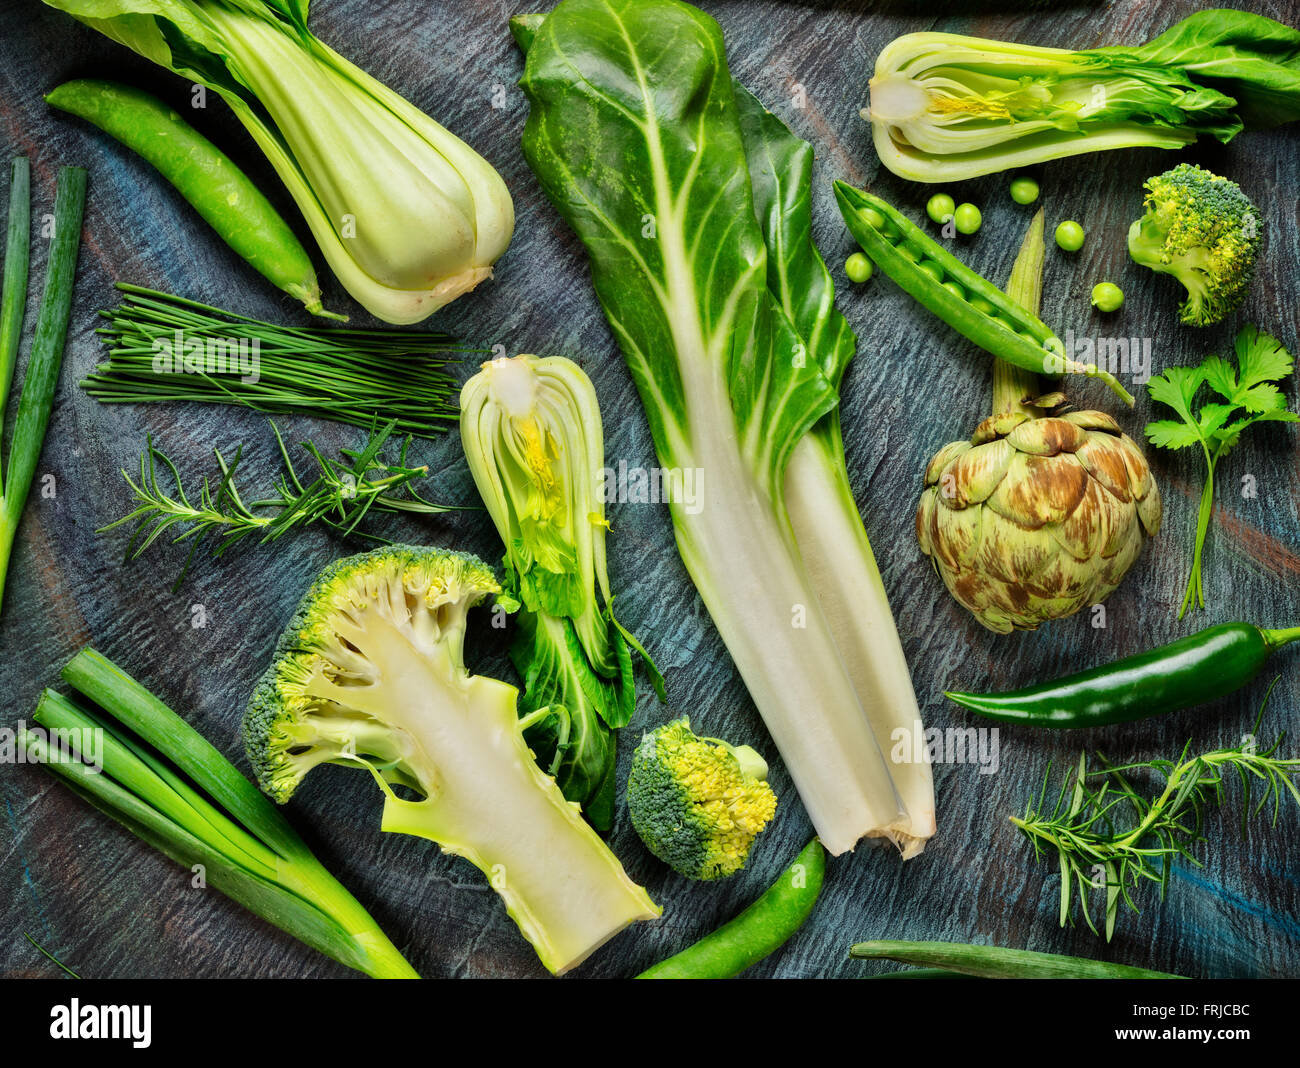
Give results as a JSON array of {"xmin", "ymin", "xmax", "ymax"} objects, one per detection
[{"xmin": 863, "ymin": 9, "xmax": 1300, "ymax": 182}]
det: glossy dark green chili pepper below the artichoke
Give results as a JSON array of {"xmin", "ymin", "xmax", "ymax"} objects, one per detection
[{"xmin": 948, "ymin": 622, "xmax": 1300, "ymax": 728}]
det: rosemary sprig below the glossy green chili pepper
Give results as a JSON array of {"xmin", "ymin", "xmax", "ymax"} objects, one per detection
[{"xmin": 1010, "ymin": 687, "xmax": 1300, "ymax": 941}]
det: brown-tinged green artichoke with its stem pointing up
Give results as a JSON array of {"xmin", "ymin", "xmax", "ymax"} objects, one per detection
[{"xmin": 917, "ymin": 212, "xmax": 1161, "ymax": 634}]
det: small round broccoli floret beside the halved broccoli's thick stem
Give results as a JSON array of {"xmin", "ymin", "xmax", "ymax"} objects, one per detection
[{"xmin": 628, "ymin": 717, "xmax": 776, "ymax": 880}]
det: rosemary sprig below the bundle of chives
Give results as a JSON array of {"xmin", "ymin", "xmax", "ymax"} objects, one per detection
[{"xmin": 98, "ymin": 422, "xmax": 455, "ymax": 586}]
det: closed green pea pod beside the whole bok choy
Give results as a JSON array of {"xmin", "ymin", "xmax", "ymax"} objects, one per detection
[{"xmin": 46, "ymin": 78, "xmax": 346, "ymax": 318}]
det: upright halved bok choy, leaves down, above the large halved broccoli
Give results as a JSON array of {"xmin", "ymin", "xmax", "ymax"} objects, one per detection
[{"xmin": 460, "ymin": 355, "xmax": 663, "ymax": 832}]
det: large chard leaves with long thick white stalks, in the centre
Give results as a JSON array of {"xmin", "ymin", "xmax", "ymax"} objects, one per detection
[{"xmin": 516, "ymin": 0, "xmax": 933, "ymax": 855}]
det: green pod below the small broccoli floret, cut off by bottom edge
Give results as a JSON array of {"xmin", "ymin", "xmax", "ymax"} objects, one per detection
[{"xmin": 637, "ymin": 838, "xmax": 826, "ymax": 978}]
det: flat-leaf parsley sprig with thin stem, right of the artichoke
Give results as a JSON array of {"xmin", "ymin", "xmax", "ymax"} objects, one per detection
[{"xmin": 1147, "ymin": 326, "xmax": 1300, "ymax": 618}]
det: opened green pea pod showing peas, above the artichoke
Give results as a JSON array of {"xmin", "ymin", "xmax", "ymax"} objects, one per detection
[{"xmin": 835, "ymin": 182, "xmax": 1134, "ymax": 408}]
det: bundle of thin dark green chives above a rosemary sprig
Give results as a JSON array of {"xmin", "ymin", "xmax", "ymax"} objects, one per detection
[{"xmin": 81, "ymin": 283, "xmax": 482, "ymax": 438}]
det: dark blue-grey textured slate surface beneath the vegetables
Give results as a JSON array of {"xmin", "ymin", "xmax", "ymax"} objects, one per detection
[{"xmin": 0, "ymin": 0, "xmax": 1300, "ymax": 977}]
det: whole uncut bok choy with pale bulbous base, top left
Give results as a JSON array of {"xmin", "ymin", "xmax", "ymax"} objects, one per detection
[{"xmin": 46, "ymin": 0, "xmax": 515, "ymax": 324}]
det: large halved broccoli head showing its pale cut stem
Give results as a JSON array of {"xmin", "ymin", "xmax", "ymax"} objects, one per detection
[{"xmin": 244, "ymin": 546, "xmax": 659, "ymax": 972}]
